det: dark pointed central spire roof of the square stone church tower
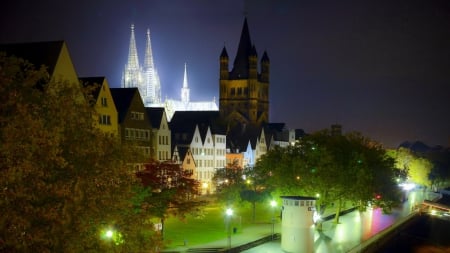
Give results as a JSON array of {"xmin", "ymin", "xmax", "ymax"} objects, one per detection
[{"xmin": 230, "ymin": 18, "xmax": 256, "ymax": 79}]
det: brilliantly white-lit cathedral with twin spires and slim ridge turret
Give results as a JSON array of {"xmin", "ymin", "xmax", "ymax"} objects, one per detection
[{"xmin": 122, "ymin": 25, "xmax": 219, "ymax": 121}]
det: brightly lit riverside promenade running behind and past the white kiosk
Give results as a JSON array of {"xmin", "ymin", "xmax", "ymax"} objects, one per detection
[{"xmin": 162, "ymin": 191, "xmax": 436, "ymax": 253}]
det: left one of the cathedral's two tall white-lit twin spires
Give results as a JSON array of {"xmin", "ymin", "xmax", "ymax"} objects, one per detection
[{"xmin": 122, "ymin": 24, "xmax": 145, "ymax": 94}]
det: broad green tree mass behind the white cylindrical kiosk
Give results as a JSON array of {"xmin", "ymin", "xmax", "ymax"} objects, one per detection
[{"xmin": 255, "ymin": 130, "xmax": 396, "ymax": 229}]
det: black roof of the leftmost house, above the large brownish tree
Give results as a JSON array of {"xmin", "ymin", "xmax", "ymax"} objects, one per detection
[{"xmin": 0, "ymin": 41, "xmax": 65, "ymax": 75}]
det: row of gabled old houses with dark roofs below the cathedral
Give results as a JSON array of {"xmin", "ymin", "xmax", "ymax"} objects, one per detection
[{"xmin": 0, "ymin": 41, "xmax": 303, "ymax": 193}]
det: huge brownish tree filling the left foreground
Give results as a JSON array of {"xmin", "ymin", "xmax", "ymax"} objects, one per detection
[{"xmin": 0, "ymin": 54, "xmax": 159, "ymax": 252}]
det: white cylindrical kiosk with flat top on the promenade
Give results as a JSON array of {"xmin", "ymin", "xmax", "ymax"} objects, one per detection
[{"xmin": 281, "ymin": 196, "xmax": 316, "ymax": 253}]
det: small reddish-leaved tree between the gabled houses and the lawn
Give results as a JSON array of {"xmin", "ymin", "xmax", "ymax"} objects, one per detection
[{"xmin": 136, "ymin": 160, "xmax": 206, "ymax": 237}]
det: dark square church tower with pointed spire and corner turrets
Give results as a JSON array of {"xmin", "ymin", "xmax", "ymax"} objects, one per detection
[{"xmin": 219, "ymin": 18, "xmax": 270, "ymax": 125}]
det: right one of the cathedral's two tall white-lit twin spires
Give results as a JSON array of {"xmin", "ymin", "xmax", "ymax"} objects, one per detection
[{"xmin": 143, "ymin": 29, "xmax": 161, "ymax": 104}]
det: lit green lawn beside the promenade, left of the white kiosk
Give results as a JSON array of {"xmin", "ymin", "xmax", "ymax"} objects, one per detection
[{"xmin": 164, "ymin": 202, "xmax": 278, "ymax": 248}]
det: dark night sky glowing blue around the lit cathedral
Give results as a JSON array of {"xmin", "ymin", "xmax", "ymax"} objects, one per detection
[{"xmin": 0, "ymin": 0, "xmax": 450, "ymax": 147}]
